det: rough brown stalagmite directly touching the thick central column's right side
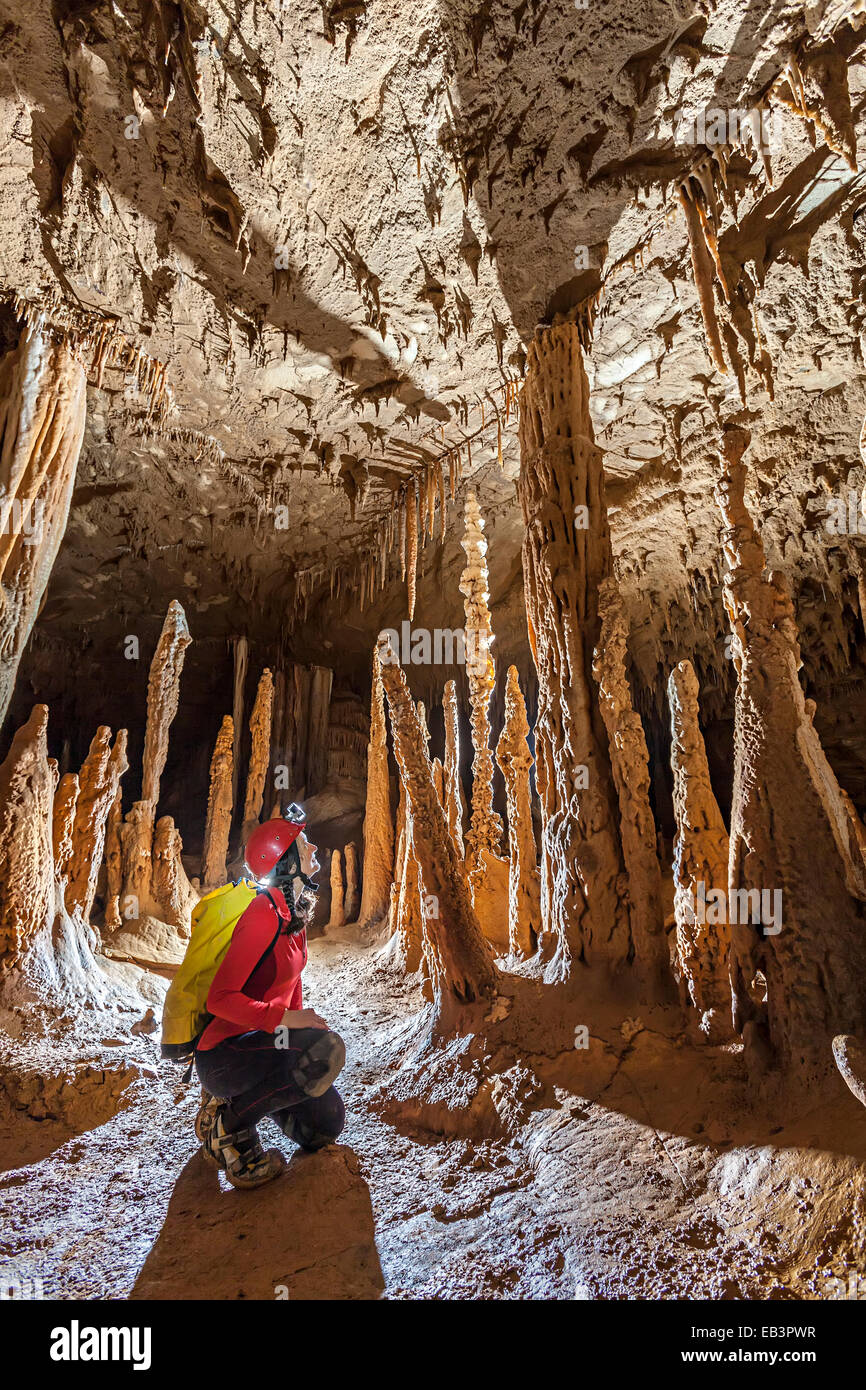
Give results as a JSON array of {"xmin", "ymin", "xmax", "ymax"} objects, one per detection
[{"xmin": 592, "ymin": 575, "xmax": 670, "ymax": 988}]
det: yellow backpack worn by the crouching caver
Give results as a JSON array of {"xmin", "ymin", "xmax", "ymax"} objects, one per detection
[{"xmin": 161, "ymin": 878, "xmax": 279, "ymax": 1066}]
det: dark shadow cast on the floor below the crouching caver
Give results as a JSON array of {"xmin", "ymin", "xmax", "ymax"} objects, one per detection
[{"xmin": 131, "ymin": 1144, "xmax": 385, "ymax": 1301}]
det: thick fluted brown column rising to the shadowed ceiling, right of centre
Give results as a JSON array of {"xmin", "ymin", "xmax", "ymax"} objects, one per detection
[{"xmin": 518, "ymin": 324, "xmax": 631, "ymax": 979}]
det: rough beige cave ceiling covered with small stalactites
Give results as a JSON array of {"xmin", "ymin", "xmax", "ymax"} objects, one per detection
[{"xmin": 0, "ymin": 0, "xmax": 866, "ymax": 695}]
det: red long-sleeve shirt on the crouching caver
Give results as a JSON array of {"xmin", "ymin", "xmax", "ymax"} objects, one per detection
[{"xmin": 199, "ymin": 888, "xmax": 307, "ymax": 1052}]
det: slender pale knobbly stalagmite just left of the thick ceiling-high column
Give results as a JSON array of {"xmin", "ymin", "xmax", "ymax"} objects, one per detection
[{"xmin": 460, "ymin": 492, "xmax": 502, "ymax": 880}]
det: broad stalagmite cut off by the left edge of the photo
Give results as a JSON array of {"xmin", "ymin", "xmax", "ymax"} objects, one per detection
[{"xmin": 0, "ymin": 705, "xmax": 54, "ymax": 969}]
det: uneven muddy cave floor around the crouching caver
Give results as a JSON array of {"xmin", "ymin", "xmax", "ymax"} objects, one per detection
[{"xmin": 0, "ymin": 938, "xmax": 866, "ymax": 1300}]
